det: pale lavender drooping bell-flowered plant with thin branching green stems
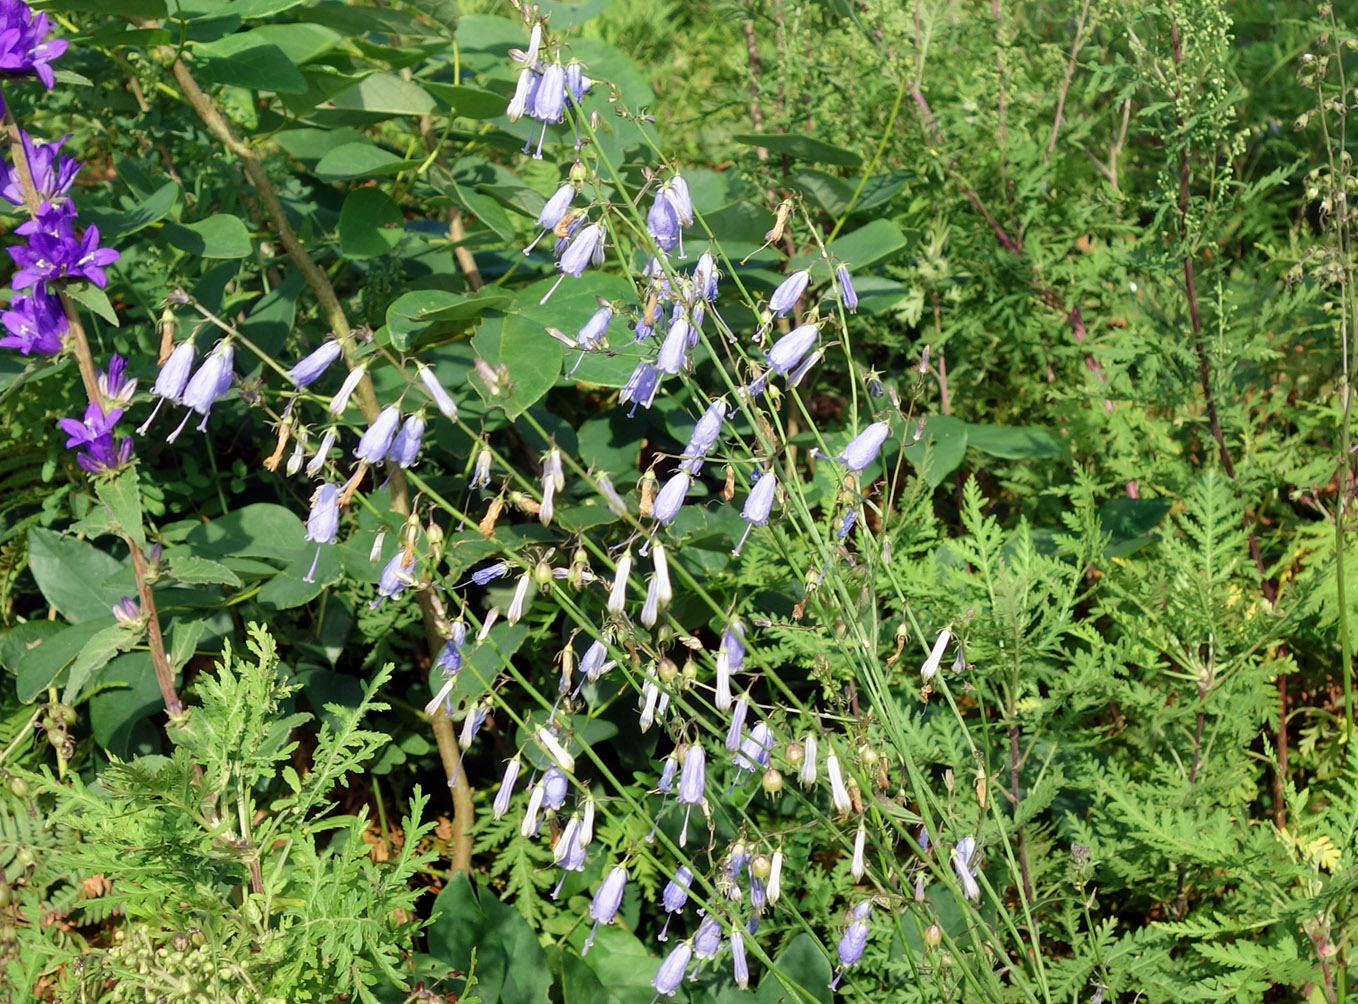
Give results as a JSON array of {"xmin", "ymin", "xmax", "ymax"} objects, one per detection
[{"xmin": 122, "ymin": 10, "xmax": 1042, "ymax": 996}]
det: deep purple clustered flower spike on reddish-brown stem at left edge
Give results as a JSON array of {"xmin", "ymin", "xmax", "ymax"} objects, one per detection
[{"xmin": 0, "ymin": 0, "xmax": 183, "ymax": 717}]
